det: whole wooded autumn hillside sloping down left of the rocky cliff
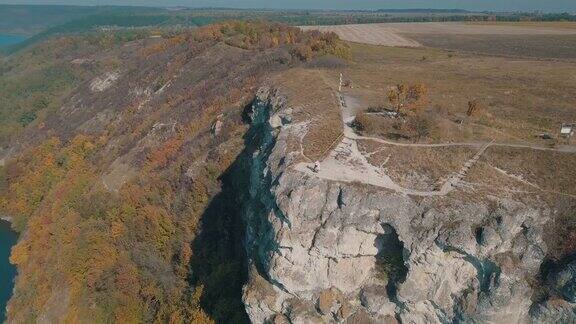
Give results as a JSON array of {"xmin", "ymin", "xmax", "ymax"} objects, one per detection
[{"xmin": 0, "ymin": 22, "xmax": 350, "ymax": 323}]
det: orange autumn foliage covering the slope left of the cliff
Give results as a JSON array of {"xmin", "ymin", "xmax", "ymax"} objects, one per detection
[{"xmin": 0, "ymin": 22, "xmax": 338, "ymax": 323}]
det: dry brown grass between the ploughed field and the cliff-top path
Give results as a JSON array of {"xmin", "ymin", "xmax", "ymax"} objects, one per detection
[{"xmin": 336, "ymin": 44, "xmax": 576, "ymax": 145}]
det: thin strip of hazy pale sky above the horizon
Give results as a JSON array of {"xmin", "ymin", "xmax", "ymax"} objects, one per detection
[{"xmin": 0, "ymin": 0, "xmax": 576, "ymax": 12}]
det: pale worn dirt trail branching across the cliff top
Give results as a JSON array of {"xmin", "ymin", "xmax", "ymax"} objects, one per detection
[{"xmin": 294, "ymin": 86, "xmax": 576, "ymax": 197}]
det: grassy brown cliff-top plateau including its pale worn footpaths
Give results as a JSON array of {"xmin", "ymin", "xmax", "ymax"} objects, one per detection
[{"xmin": 295, "ymin": 39, "xmax": 576, "ymax": 203}]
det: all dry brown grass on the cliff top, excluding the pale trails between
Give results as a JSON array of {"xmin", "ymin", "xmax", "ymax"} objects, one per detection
[{"xmin": 281, "ymin": 35, "xmax": 576, "ymax": 205}]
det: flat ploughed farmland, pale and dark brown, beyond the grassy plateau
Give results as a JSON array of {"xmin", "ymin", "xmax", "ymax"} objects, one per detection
[{"xmin": 301, "ymin": 22, "xmax": 576, "ymax": 59}]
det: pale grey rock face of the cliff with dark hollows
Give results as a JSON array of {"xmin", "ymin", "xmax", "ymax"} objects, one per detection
[{"xmin": 244, "ymin": 88, "xmax": 576, "ymax": 323}]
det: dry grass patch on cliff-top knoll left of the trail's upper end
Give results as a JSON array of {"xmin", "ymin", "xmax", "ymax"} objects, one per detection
[{"xmin": 275, "ymin": 69, "xmax": 343, "ymax": 161}]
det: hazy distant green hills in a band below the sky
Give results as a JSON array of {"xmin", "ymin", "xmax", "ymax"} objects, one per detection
[{"xmin": 0, "ymin": 5, "xmax": 576, "ymax": 53}]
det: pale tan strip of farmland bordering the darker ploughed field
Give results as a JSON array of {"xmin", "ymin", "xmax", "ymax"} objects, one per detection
[{"xmin": 301, "ymin": 23, "xmax": 576, "ymax": 47}]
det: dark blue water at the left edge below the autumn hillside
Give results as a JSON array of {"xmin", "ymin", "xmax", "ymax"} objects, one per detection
[{"xmin": 0, "ymin": 220, "xmax": 18, "ymax": 322}]
